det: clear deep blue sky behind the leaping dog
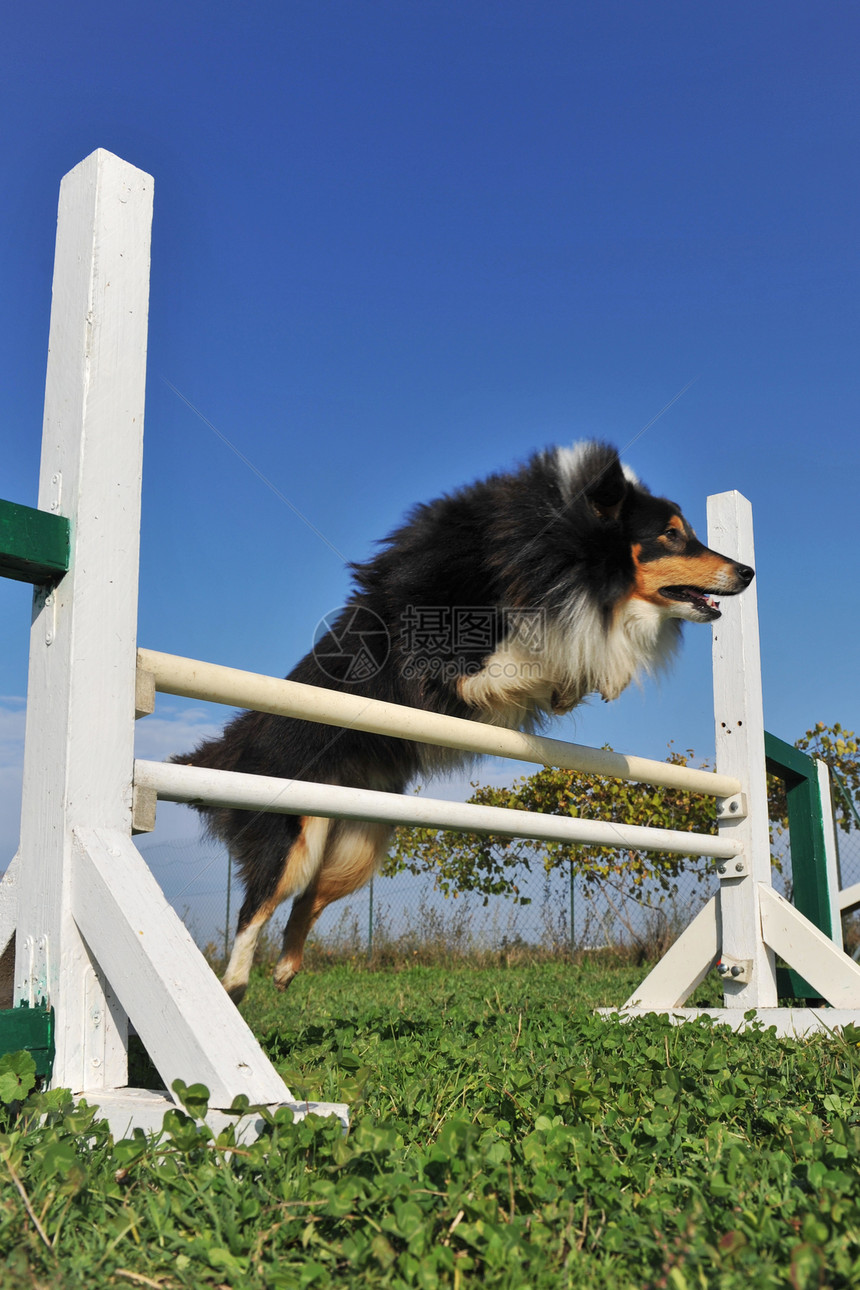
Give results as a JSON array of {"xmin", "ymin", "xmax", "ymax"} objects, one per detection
[{"xmin": 0, "ymin": 0, "xmax": 860, "ymax": 908}]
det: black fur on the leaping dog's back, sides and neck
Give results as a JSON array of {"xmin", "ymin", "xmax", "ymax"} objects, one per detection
[{"xmin": 173, "ymin": 444, "xmax": 752, "ymax": 980}]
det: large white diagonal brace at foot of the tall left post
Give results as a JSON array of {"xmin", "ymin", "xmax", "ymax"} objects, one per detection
[{"xmin": 71, "ymin": 827, "xmax": 294, "ymax": 1109}]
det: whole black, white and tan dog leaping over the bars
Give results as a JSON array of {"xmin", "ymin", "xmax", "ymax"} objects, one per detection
[{"xmin": 173, "ymin": 442, "xmax": 753, "ymax": 1000}]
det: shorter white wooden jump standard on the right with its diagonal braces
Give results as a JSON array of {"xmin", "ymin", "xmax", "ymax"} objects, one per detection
[{"xmin": 611, "ymin": 493, "xmax": 860, "ymax": 1035}]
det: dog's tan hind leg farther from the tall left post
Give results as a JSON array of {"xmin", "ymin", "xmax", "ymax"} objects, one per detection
[{"xmin": 273, "ymin": 820, "xmax": 392, "ymax": 989}]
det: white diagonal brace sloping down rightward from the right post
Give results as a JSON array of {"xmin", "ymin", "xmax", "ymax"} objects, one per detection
[{"xmin": 758, "ymin": 884, "xmax": 860, "ymax": 1009}]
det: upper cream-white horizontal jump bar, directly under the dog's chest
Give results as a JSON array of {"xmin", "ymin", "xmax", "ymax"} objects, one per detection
[{"xmin": 138, "ymin": 649, "xmax": 741, "ymax": 794}]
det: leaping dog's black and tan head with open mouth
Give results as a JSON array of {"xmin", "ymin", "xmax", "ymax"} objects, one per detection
[{"xmin": 584, "ymin": 445, "xmax": 754, "ymax": 623}]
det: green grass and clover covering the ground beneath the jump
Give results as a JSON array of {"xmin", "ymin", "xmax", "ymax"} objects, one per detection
[{"xmin": 0, "ymin": 964, "xmax": 860, "ymax": 1290}]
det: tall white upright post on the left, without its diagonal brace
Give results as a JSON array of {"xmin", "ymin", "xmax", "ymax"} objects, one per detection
[{"xmin": 14, "ymin": 150, "xmax": 152, "ymax": 1090}]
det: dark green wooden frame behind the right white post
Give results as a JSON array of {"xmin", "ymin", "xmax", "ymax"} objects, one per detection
[{"xmin": 765, "ymin": 731, "xmax": 833, "ymax": 1000}]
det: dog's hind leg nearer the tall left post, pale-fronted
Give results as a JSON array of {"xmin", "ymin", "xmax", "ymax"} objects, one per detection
[{"xmin": 222, "ymin": 815, "xmax": 331, "ymax": 1004}]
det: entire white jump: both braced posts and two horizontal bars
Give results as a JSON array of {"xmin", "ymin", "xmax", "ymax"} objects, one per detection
[{"xmin": 0, "ymin": 151, "xmax": 860, "ymax": 1134}]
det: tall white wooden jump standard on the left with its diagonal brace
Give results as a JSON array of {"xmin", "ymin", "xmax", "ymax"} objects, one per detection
[{"xmin": 0, "ymin": 150, "xmax": 346, "ymax": 1134}]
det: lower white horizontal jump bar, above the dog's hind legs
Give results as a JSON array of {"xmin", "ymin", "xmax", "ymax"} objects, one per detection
[{"xmin": 134, "ymin": 761, "xmax": 740, "ymax": 860}]
